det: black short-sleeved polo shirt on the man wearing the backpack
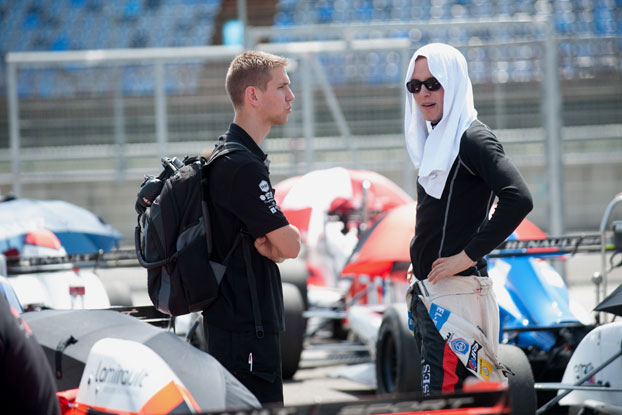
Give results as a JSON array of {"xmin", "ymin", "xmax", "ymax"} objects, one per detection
[{"xmin": 203, "ymin": 123, "xmax": 289, "ymax": 333}]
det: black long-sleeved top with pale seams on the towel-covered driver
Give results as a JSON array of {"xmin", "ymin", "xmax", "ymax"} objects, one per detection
[{"xmin": 410, "ymin": 120, "xmax": 533, "ymax": 279}]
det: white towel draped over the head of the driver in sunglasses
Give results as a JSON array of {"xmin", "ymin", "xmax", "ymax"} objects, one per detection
[{"xmin": 404, "ymin": 43, "xmax": 477, "ymax": 199}]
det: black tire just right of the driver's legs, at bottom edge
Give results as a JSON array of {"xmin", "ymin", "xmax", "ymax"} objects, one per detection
[{"xmin": 499, "ymin": 344, "xmax": 537, "ymax": 414}]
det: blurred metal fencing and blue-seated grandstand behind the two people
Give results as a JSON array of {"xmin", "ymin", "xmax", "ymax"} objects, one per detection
[{"xmin": 0, "ymin": 0, "xmax": 622, "ymax": 245}]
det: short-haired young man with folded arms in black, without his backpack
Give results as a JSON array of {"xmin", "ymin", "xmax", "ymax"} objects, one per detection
[{"xmin": 203, "ymin": 51, "xmax": 300, "ymax": 403}]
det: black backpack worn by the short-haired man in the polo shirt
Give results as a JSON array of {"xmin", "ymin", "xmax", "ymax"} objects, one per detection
[{"xmin": 134, "ymin": 143, "xmax": 245, "ymax": 316}]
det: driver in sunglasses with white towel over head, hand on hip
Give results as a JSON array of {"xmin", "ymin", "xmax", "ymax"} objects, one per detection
[{"xmin": 404, "ymin": 43, "xmax": 533, "ymax": 394}]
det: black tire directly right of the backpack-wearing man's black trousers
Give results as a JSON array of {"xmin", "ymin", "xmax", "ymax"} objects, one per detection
[{"xmin": 281, "ymin": 283, "xmax": 305, "ymax": 379}]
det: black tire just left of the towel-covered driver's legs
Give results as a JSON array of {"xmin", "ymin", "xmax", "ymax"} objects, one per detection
[{"xmin": 376, "ymin": 303, "xmax": 421, "ymax": 393}]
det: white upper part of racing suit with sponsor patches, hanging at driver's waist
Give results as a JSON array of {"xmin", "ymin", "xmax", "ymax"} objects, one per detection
[{"xmin": 406, "ymin": 276, "xmax": 507, "ymax": 382}]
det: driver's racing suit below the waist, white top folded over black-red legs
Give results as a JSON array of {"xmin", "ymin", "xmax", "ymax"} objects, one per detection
[{"xmin": 406, "ymin": 276, "xmax": 507, "ymax": 394}]
